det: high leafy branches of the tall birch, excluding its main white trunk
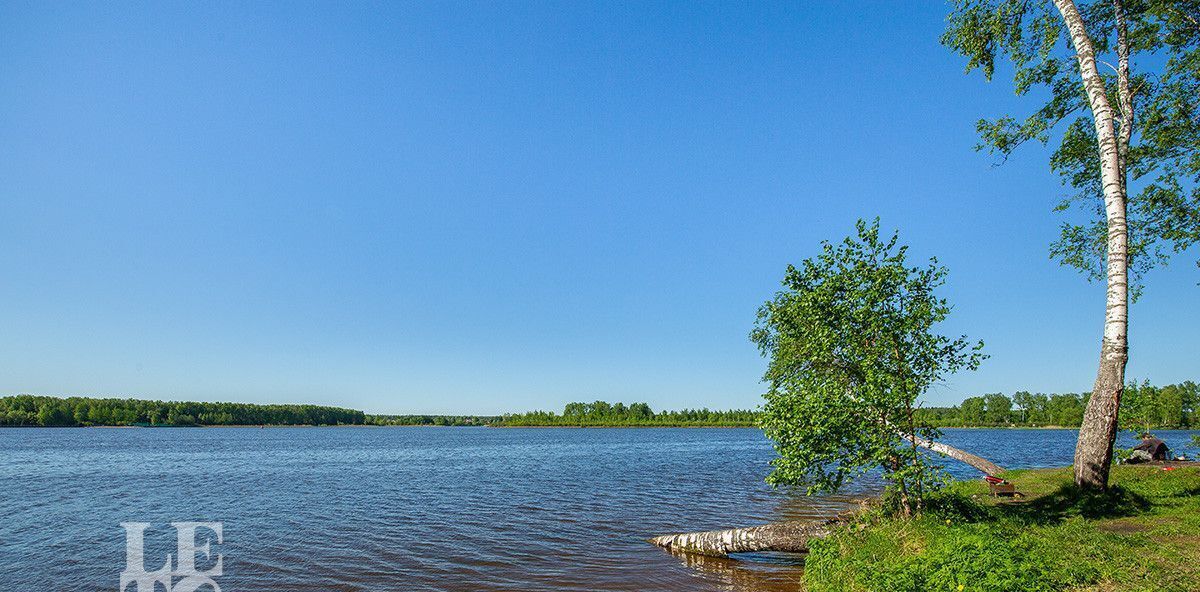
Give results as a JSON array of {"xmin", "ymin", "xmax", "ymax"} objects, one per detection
[{"xmin": 942, "ymin": 0, "xmax": 1200, "ymax": 291}]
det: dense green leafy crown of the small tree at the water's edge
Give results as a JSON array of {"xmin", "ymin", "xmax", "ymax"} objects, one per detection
[{"xmin": 750, "ymin": 220, "xmax": 984, "ymax": 506}]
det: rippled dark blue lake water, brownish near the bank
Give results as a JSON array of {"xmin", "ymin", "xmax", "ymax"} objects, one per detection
[{"xmin": 0, "ymin": 427, "xmax": 1195, "ymax": 592}]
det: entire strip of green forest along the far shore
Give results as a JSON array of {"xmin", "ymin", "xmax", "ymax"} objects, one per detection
[{"xmin": 0, "ymin": 381, "xmax": 1200, "ymax": 431}]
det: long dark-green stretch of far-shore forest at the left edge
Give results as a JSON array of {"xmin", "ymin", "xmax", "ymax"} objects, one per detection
[{"xmin": 0, "ymin": 395, "xmax": 366, "ymax": 426}]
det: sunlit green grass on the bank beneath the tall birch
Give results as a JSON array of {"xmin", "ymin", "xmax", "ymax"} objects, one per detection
[{"xmin": 804, "ymin": 466, "xmax": 1200, "ymax": 592}]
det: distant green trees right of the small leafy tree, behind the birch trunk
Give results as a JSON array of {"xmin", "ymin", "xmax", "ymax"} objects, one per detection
[{"xmin": 917, "ymin": 381, "xmax": 1200, "ymax": 431}]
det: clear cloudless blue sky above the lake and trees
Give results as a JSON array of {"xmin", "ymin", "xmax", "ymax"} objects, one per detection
[{"xmin": 0, "ymin": 2, "xmax": 1200, "ymax": 413}]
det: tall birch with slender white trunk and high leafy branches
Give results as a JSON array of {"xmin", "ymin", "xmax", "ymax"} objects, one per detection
[{"xmin": 942, "ymin": 0, "xmax": 1200, "ymax": 489}]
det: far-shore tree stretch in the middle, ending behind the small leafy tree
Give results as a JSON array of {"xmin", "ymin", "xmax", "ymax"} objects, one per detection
[{"xmin": 497, "ymin": 401, "xmax": 758, "ymax": 427}]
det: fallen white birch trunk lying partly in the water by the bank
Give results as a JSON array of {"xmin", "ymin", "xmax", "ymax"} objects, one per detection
[{"xmin": 650, "ymin": 520, "xmax": 838, "ymax": 557}]
